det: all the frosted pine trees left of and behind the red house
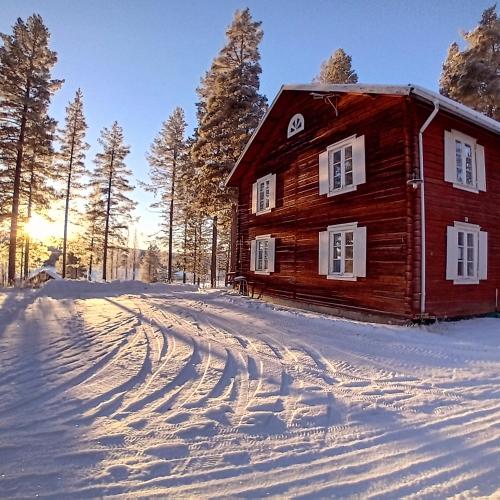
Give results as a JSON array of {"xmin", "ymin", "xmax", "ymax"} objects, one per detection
[{"xmin": 0, "ymin": 6, "xmax": 500, "ymax": 286}]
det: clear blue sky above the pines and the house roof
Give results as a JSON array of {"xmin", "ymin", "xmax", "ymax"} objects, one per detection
[{"xmin": 0, "ymin": 0, "xmax": 494, "ymax": 246}]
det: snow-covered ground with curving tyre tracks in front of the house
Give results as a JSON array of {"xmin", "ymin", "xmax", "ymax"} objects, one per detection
[{"xmin": 0, "ymin": 281, "xmax": 500, "ymax": 498}]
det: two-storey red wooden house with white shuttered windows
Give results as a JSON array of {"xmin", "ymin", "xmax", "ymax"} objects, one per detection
[{"xmin": 227, "ymin": 84, "xmax": 500, "ymax": 321}]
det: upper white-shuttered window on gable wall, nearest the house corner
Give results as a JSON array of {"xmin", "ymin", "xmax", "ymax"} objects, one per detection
[{"xmin": 319, "ymin": 135, "xmax": 366, "ymax": 196}]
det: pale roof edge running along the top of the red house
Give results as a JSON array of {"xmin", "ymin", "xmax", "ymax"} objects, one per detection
[{"xmin": 226, "ymin": 83, "xmax": 500, "ymax": 185}]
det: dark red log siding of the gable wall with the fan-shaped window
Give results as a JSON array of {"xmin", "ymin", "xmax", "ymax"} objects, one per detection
[{"xmin": 238, "ymin": 92, "xmax": 419, "ymax": 318}]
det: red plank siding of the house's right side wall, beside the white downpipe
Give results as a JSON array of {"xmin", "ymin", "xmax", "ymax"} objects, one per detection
[{"xmin": 416, "ymin": 104, "xmax": 500, "ymax": 317}]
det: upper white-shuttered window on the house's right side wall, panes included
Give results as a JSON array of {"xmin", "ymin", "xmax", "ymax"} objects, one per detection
[{"xmin": 444, "ymin": 130, "xmax": 486, "ymax": 193}]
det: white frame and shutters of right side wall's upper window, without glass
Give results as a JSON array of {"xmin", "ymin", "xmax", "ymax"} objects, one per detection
[{"xmin": 444, "ymin": 130, "xmax": 486, "ymax": 193}]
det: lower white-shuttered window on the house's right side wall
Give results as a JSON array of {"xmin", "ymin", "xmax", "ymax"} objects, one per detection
[{"xmin": 446, "ymin": 222, "xmax": 488, "ymax": 284}]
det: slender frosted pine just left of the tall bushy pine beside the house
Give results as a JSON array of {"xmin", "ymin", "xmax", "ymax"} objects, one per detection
[{"xmin": 145, "ymin": 108, "xmax": 187, "ymax": 281}]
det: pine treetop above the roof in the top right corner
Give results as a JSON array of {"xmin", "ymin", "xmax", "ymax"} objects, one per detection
[{"xmin": 439, "ymin": 5, "xmax": 500, "ymax": 120}]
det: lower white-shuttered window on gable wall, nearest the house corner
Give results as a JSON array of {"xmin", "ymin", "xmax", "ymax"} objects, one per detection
[{"xmin": 319, "ymin": 222, "xmax": 366, "ymax": 281}]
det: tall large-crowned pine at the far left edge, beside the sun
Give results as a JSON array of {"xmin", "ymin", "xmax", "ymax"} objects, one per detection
[{"xmin": 0, "ymin": 14, "xmax": 62, "ymax": 283}]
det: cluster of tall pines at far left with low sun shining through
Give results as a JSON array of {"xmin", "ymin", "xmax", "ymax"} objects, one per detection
[{"xmin": 0, "ymin": 14, "xmax": 135, "ymax": 284}]
